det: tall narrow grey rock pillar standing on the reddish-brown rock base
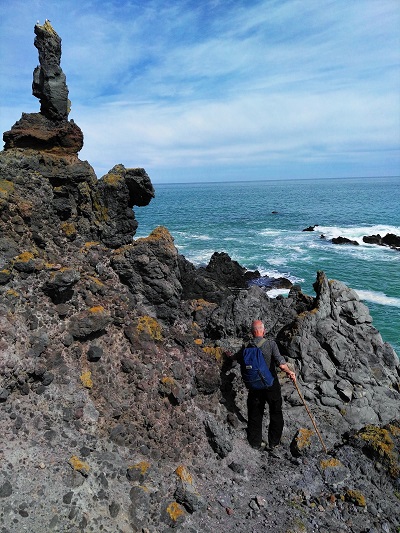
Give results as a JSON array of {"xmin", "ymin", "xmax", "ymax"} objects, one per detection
[{"xmin": 32, "ymin": 21, "xmax": 69, "ymax": 121}]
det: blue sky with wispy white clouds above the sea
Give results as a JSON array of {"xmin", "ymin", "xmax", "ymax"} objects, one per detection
[{"xmin": 0, "ymin": 0, "xmax": 400, "ymax": 183}]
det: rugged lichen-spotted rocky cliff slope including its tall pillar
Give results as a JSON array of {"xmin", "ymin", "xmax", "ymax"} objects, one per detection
[{"xmin": 0, "ymin": 21, "xmax": 400, "ymax": 533}]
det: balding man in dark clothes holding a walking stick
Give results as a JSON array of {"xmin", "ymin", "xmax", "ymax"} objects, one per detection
[{"xmin": 234, "ymin": 320, "xmax": 296, "ymax": 455}]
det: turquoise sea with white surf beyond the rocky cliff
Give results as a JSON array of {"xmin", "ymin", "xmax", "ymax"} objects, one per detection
[{"xmin": 135, "ymin": 177, "xmax": 400, "ymax": 356}]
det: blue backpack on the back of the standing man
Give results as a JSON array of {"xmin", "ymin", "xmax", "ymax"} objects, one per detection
[{"xmin": 240, "ymin": 339, "xmax": 274, "ymax": 389}]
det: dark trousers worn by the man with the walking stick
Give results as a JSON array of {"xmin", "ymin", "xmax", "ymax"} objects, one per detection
[{"xmin": 247, "ymin": 378, "xmax": 283, "ymax": 446}]
